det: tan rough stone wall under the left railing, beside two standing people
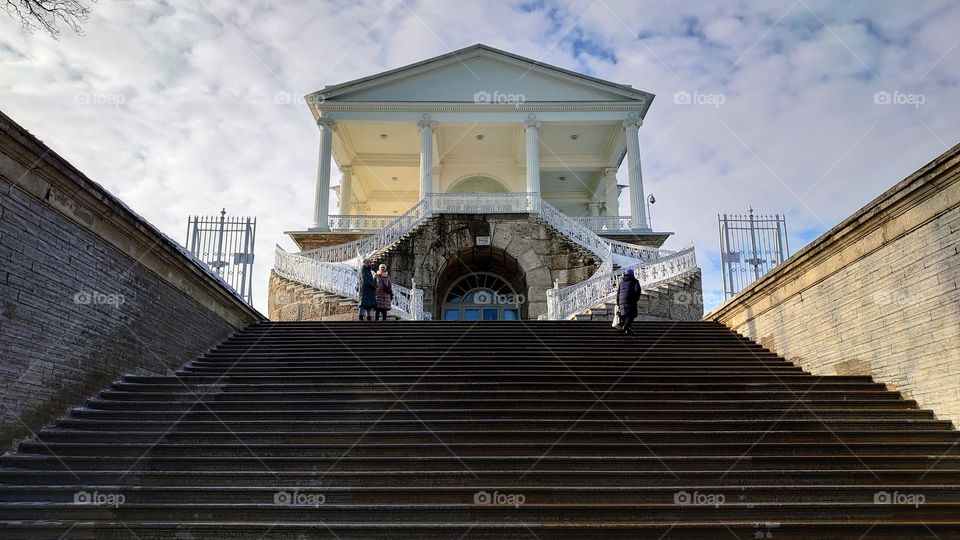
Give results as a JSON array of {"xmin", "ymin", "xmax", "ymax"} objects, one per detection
[{"xmin": 267, "ymin": 272, "xmax": 358, "ymax": 321}]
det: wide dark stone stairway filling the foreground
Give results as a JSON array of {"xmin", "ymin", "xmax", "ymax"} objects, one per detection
[{"xmin": 0, "ymin": 321, "xmax": 960, "ymax": 540}]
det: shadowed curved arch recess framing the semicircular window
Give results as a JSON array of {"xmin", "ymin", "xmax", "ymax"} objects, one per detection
[{"xmin": 433, "ymin": 245, "xmax": 529, "ymax": 319}]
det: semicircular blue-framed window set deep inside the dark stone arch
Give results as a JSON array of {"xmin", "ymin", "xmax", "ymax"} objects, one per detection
[{"xmin": 442, "ymin": 272, "xmax": 524, "ymax": 321}]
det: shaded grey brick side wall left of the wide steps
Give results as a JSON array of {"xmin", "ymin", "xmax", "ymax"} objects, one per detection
[{"xmin": 0, "ymin": 115, "xmax": 261, "ymax": 450}]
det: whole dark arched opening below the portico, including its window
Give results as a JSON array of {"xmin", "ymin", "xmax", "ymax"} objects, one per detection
[{"xmin": 434, "ymin": 246, "xmax": 527, "ymax": 321}]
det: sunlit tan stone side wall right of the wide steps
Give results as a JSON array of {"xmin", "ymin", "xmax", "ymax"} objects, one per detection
[{"xmin": 706, "ymin": 146, "xmax": 960, "ymax": 423}]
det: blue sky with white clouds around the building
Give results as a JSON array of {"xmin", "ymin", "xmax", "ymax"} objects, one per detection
[{"xmin": 0, "ymin": 0, "xmax": 960, "ymax": 313}]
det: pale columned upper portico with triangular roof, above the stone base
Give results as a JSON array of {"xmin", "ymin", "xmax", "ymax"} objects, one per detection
[{"xmin": 291, "ymin": 45, "xmax": 669, "ymax": 249}]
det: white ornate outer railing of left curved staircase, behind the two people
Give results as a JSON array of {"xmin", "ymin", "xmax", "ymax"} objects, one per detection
[{"xmin": 273, "ymin": 246, "xmax": 423, "ymax": 320}]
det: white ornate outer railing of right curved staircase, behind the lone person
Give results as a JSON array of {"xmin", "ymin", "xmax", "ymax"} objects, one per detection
[{"xmin": 546, "ymin": 244, "xmax": 697, "ymax": 320}]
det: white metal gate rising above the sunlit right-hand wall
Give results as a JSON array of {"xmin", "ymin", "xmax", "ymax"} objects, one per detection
[{"xmin": 717, "ymin": 208, "xmax": 790, "ymax": 299}]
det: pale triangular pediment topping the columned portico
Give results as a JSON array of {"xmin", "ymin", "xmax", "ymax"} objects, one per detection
[{"xmin": 319, "ymin": 45, "xmax": 652, "ymax": 103}]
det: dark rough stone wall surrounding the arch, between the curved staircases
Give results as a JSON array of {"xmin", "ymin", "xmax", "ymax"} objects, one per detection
[{"xmin": 379, "ymin": 215, "xmax": 597, "ymax": 319}]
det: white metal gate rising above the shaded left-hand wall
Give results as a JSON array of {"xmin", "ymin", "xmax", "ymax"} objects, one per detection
[{"xmin": 187, "ymin": 209, "xmax": 257, "ymax": 304}]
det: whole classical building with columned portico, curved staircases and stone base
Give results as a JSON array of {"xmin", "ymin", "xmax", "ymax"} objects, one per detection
[{"xmin": 270, "ymin": 45, "xmax": 702, "ymax": 320}]
